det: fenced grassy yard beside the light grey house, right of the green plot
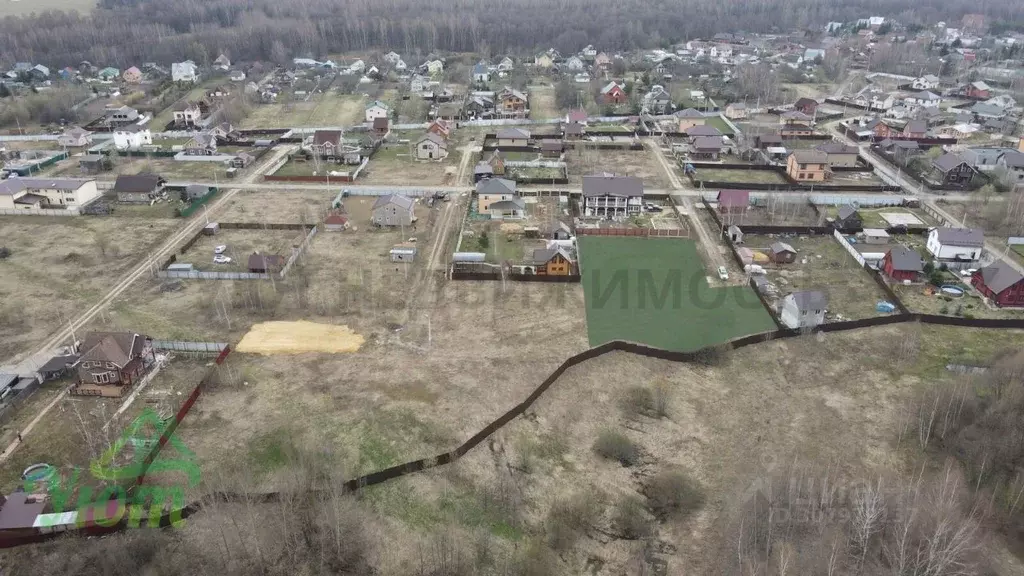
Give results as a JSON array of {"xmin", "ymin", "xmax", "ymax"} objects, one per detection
[{"xmin": 743, "ymin": 235, "xmax": 886, "ymax": 320}]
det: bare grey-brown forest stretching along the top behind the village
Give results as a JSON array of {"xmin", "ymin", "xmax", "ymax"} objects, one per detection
[{"xmin": 0, "ymin": 0, "xmax": 1024, "ymax": 68}]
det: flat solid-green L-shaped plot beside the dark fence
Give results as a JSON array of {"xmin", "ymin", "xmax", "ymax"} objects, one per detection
[{"xmin": 579, "ymin": 236, "xmax": 776, "ymax": 351}]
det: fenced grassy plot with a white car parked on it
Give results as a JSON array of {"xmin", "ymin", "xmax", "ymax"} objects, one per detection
[{"xmin": 177, "ymin": 223, "xmax": 303, "ymax": 272}]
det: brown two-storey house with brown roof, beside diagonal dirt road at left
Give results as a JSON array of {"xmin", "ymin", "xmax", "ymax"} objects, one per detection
[{"xmin": 71, "ymin": 332, "xmax": 157, "ymax": 398}]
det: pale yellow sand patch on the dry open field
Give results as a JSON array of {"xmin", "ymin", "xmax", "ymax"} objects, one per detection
[{"xmin": 236, "ymin": 320, "xmax": 366, "ymax": 355}]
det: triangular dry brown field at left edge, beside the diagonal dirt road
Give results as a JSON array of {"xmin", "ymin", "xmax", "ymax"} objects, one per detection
[{"xmin": 0, "ymin": 216, "xmax": 180, "ymax": 360}]
